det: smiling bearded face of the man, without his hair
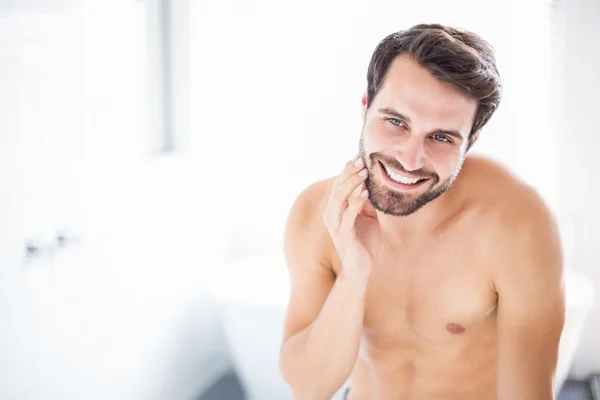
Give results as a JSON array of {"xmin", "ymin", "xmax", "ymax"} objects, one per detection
[{"xmin": 359, "ymin": 55, "xmax": 477, "ymax": 216}]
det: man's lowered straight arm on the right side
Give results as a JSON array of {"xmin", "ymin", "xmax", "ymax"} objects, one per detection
[{"xmin": 494, "ymin": 192, "xmax": 565, "ymax": 400}]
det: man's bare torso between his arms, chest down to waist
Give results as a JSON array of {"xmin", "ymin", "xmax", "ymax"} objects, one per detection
[{"xmin": 324, "ymin": 155, "xmax": 516, "ymax": 400}]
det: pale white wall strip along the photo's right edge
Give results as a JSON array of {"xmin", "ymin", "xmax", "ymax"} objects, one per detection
[{"xmin": 560, "ymin": 0, "xmax": 600, "ymax": 378}]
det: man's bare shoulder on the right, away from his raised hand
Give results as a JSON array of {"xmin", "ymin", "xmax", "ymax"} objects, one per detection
[{"xmin": 461, "ymin": 156, "xmax": 562, "ymax": 271}]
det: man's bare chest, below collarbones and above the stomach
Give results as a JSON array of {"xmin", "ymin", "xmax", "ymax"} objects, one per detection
[{"xmin": 364, "ymin": 238, "xmax": 496, "ymax": 349}]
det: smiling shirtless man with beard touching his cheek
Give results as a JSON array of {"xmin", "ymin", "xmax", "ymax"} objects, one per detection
[{"xmin": 280, "ymin": 25, "xmax": 565, "ymax": 400}]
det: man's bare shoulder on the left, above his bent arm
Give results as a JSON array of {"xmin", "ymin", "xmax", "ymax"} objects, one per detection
[{"xmin": 284, "ymin": 178, "xmax": 335, "ymax": 268}]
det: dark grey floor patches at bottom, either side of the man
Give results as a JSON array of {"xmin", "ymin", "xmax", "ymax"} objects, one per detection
[{"xmin": 198, "ymin": 372, "xmax": 600, "ymax": 400}]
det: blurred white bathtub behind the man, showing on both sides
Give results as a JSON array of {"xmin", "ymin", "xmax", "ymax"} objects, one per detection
[{"xmin": 212, "ymin": 254, "xmax": 594, "ymax": 400}]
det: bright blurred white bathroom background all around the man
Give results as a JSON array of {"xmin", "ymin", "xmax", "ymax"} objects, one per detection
[{"xmin": 0, "ymin": 0, "xmax": 600, "ymax": 400}]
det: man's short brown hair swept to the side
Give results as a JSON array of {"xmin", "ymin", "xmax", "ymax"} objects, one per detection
[{"xmin": 367, "ymin": 24, "xmax": 502, "ymax": 147}]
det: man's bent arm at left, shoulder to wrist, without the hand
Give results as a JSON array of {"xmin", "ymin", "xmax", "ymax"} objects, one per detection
[{"xmin": 280, "ymin": 182, "xmax": 367, "ymax": 400}]
